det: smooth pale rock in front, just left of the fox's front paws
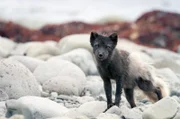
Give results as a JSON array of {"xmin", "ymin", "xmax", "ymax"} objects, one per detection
[{"xmin": 77, "ymin": 101, "xmax": 107, "ymax": 118}]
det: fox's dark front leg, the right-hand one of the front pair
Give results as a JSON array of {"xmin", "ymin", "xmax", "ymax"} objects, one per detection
[{"xmin": 115, "ymin": 78, "xmax": 123, "ymax": 107}]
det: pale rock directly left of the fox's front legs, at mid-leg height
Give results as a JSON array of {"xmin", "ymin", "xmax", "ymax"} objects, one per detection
[{"xmin": 85, "ymin": 76, "xmax": 104, "ymax": 96}]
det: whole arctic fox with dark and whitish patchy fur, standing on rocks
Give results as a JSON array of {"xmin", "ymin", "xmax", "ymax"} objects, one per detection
[{"xmin": 90, "ymin": 32, "xmax": 169, "ymax": 110}]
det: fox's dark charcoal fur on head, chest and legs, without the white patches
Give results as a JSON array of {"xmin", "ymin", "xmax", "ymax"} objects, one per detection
[{"xmin": 90, "ymin": 32, "xmax": 162, "ymax": 109}]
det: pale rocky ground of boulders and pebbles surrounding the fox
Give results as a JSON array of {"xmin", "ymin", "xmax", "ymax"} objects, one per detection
[{"xmin": 0, "ymin": 34, "xmax": 180, "ymax": 119}]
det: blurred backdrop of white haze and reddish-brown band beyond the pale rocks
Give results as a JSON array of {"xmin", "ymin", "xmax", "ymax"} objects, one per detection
[{"xmin": 0, "ymin": 0, "xmax": 180, "ymax": 52}]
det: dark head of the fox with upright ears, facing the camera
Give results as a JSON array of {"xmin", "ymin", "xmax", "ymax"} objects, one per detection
[{"xmin": 90, "ymin": 32, "xmax": 118, "ymax": 61}]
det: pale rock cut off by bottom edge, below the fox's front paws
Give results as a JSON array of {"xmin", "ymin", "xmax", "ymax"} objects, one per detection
[{"xmin": 96, "ymin": 113, "xmax": 120, "ymax": 119}]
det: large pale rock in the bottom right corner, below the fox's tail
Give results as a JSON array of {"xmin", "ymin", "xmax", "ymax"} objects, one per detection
[{"xmin": 143, "ymin": 97, "xmax": 180, "ymax": 119}]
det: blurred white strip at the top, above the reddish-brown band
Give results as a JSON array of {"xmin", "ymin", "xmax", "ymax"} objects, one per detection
[{"xmin": 0, "ymin": 0, "xmax": 180, "ymax": 28}]
